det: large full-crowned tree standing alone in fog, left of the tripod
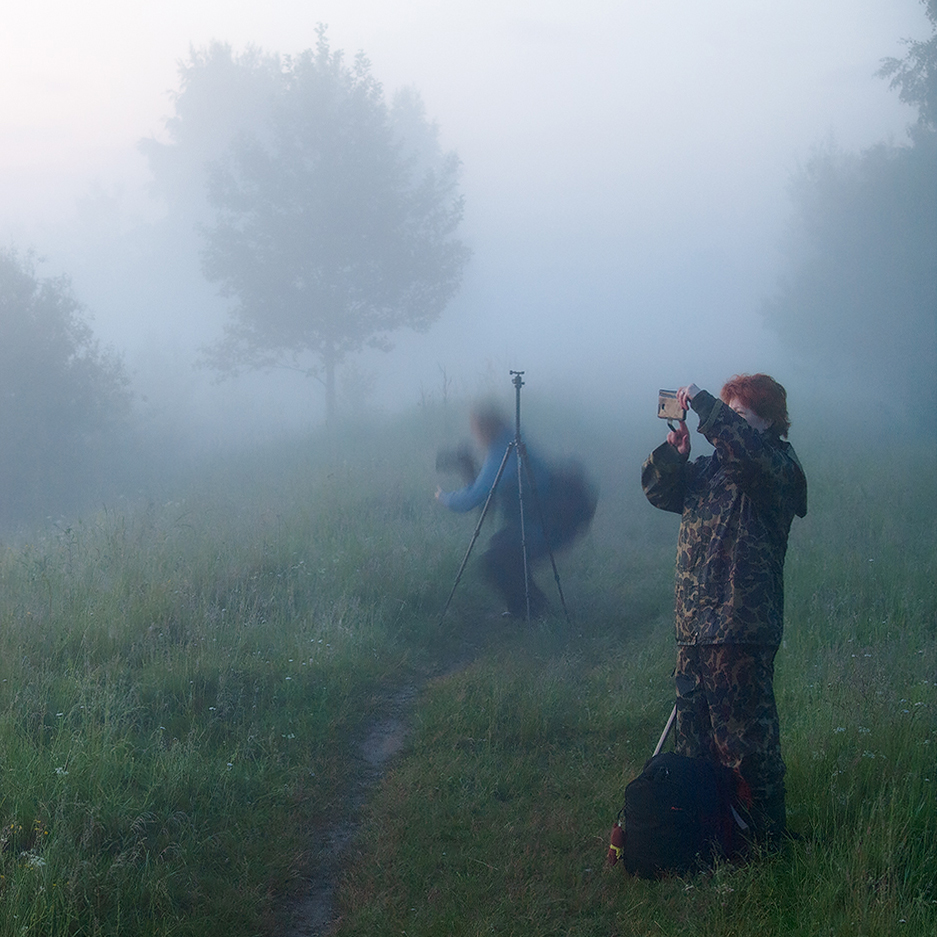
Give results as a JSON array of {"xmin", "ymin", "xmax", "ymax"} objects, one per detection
[{"xmin": 145, "ymin": 26, "xmax": 469, "ymax": 418}]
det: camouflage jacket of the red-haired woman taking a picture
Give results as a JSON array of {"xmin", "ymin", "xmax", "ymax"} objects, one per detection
[{"xmin": 641, "ymin": 391, "xmax": 807, "ymax": 645}]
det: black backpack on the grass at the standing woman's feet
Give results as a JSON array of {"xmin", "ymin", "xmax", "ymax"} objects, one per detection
[{"xmin": 608, "ymin": 752, "xmax": 745, "ymax": 878}]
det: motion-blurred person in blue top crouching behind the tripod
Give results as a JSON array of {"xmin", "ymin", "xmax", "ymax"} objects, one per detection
[{"xmin": 436, "ymin": 403, "xmax": 596, "ymax": 618}]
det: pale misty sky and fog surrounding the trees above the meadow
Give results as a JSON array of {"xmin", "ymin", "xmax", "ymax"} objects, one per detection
[{"xmin": 0, "ymin": 0, "xmax": 929, "ymax": 441}]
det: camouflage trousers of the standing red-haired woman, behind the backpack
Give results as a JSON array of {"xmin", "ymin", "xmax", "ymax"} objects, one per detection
[{"xmin": 674, "ymin": 644, "xmax": 786, "ymax": 836}]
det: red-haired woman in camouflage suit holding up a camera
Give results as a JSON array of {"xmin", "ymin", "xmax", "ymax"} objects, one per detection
[{"xmin": 641, "ymin": 374, "xmax": 807, "ymax": 845}]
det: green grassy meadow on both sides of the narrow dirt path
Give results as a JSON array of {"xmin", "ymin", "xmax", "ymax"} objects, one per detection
[{"xmin": 0, "ymin": 398, "xmax": 937, "ymax": 937}]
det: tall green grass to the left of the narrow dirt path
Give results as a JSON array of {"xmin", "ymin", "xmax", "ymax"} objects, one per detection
[{"xmin": 0, "ymin": 414, "xmax": 458, "ymax": 935}]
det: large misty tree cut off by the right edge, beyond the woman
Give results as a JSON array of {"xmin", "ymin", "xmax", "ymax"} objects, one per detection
[{"xmin": 766, "ymin": 0, "xmax": 937, "ymax": 416}]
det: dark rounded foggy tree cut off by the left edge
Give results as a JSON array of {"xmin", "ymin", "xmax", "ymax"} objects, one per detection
[{"xmin": 0, "ymin": 250, "xmax": 130, "ymax": 520}]
